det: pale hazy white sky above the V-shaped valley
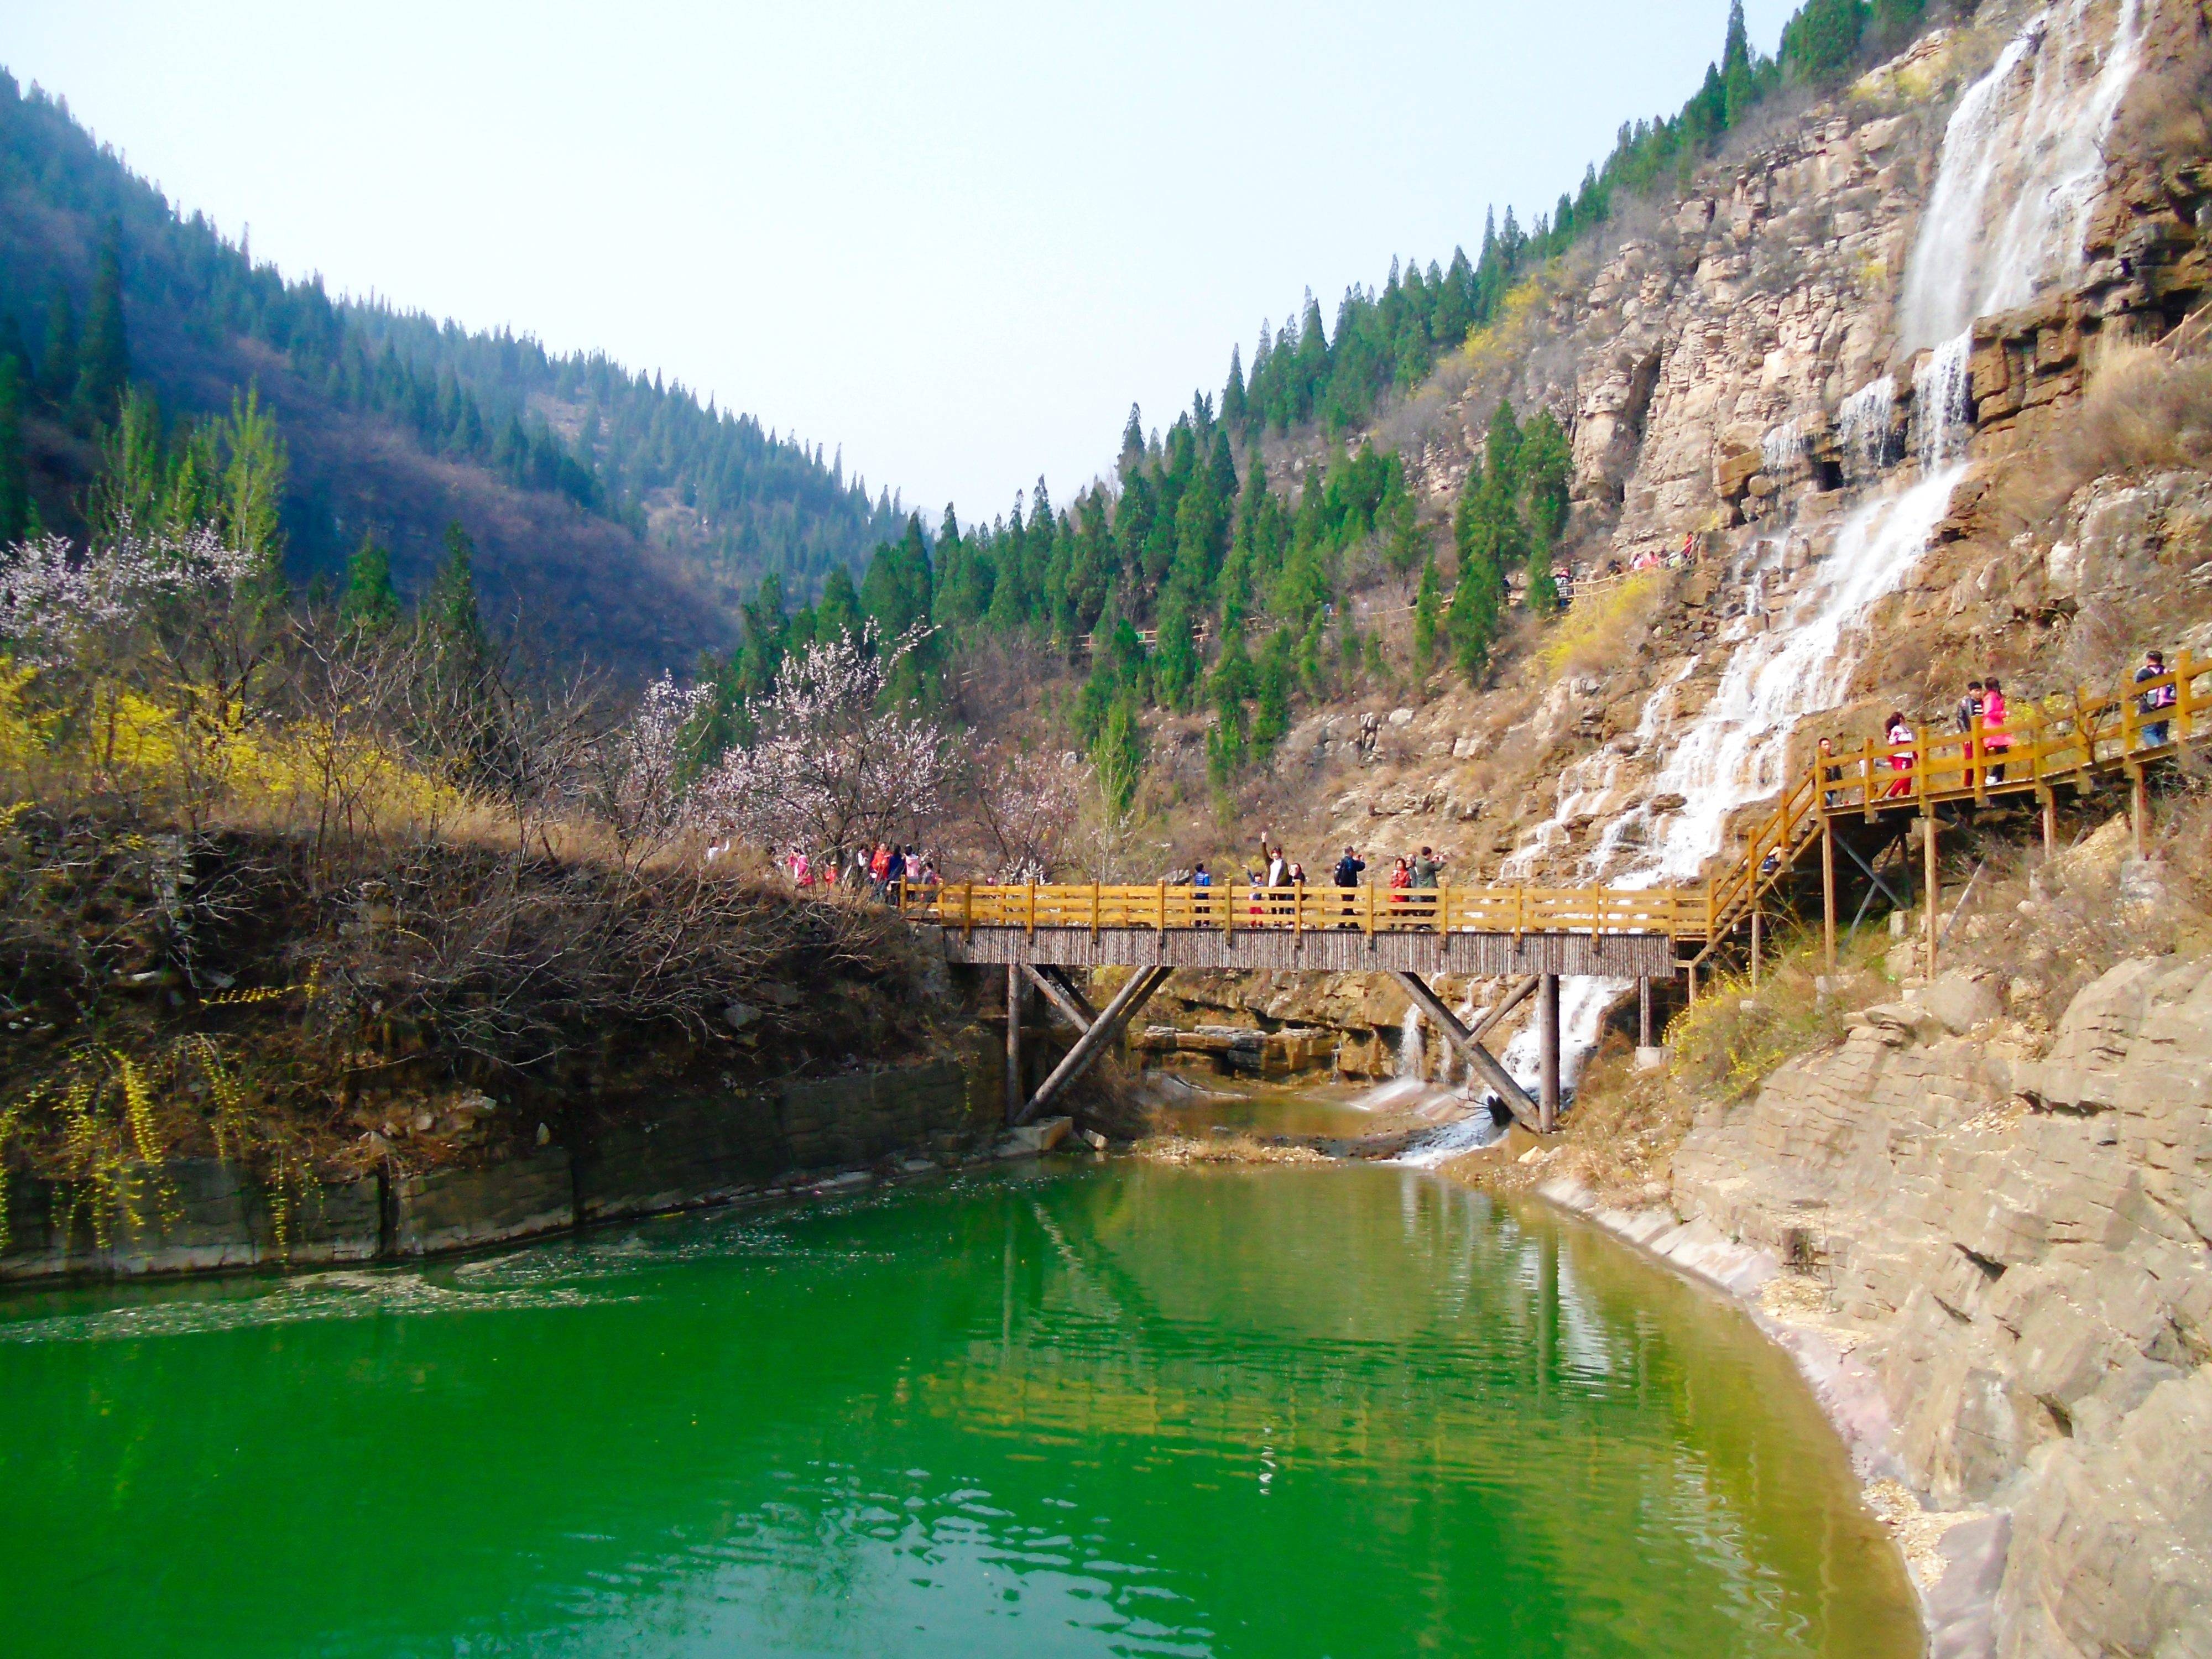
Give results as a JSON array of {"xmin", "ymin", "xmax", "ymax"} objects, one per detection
[{"xmin": 0, "ymin": 0, "xmax": 1794, "ymax": 518}]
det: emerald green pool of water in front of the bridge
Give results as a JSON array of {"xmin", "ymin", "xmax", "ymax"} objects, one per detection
[{"xmin": 0, "ymin": 1164, "xmax": 1920, "ymax": 1659}]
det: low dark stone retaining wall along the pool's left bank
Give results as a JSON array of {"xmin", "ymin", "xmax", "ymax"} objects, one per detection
[{"xmin": 0, "ymin": 1057, "xmax": 1002, "ymax": 1281}]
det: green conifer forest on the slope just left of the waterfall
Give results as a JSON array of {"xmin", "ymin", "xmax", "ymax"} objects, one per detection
[{"xmin": 703, "ymin": 0, "xmax": 1924, "ymax": 805}]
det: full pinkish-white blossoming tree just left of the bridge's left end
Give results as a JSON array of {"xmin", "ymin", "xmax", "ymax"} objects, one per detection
[{"xmin": 692, "ymin": 624, "xmax": 951, "ymax": 856}]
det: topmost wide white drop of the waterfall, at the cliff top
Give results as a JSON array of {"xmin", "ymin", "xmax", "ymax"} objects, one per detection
[{"xmin": 1898, "ymin": 0, "xmax": 2143, "ymax": 352}]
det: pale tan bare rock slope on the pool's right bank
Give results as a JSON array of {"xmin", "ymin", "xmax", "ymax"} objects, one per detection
[{"xmin": 1674, "ymin": 958, "xmax": 2212, "ymax": 1659}]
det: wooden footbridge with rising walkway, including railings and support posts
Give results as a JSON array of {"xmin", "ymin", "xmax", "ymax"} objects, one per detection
[{"xmin": 898, "ymin": 653, "xmax": 2212, "ymax": 1133}]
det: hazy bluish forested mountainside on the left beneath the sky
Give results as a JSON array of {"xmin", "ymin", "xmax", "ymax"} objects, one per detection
[{"xmin": 0, "ymin": 73, "xmax": 898, "ymax": 666}]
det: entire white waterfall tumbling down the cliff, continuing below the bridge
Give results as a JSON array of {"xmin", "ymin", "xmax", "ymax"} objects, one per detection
[{"xmin": 1405, "ymin": 0, "xmax": 2141, "ymax": 1164}]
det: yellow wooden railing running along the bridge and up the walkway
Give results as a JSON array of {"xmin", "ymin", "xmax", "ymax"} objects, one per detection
[{"xmin": 898, "ymin": 653, "xmax": 2212, "ymax": 949}]
